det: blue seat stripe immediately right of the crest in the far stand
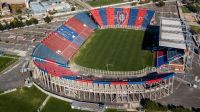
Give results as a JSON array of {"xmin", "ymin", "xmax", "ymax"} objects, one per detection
[{"xmin": 128, "ymin": 9, "xmax": 138, "ymax": 26}]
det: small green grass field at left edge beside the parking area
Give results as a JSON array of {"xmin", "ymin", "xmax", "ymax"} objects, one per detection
[{"xmin": 0, "ymin": 55, "xmax": 18, "ymax": 72}]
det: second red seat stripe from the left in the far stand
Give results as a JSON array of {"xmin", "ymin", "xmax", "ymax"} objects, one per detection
[{"xmin": 106, "ymin": 7, "xmax": 115, "ymax": 25}]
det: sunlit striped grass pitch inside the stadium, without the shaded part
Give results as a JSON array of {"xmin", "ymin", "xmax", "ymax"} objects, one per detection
[{"xmin": 74, "ymin": 29, "xmax": 153, "ymax": 71}]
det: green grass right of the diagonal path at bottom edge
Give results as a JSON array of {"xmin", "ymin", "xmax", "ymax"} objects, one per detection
[{"xmin": 42, "ymin": 97, "xmax": 87, "ymax": 112}]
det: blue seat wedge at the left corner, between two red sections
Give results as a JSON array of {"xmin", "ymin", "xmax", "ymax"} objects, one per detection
[{"xmin": 32, "ymin": 43, "xmax": 68, "ymax": 67}]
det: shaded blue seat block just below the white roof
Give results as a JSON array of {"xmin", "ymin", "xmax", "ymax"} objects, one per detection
[{"xmin": 167, "ymin": 48, "xmax": 184, "ymax": 61}]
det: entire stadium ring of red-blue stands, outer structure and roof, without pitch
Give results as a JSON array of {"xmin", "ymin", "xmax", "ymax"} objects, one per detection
[{"xmin": 31, "ymin": 8, "xmax": 188, "ymax": 108}]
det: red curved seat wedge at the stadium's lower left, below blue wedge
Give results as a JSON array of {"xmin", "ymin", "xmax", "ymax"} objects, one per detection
[{"xmin": 34, "ymin": 61, "xmax": 76, "ymax": 77}]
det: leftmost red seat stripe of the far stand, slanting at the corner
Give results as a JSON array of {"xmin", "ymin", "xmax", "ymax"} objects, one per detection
[{"xmin": 90, "ymin": 9, "xmax": 103, "ymax": 27}]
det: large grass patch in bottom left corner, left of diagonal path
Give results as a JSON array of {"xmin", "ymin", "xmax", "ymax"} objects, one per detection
[{"xmin": 0, "ymin": 86, "xmax": 47, "ymax": 112}]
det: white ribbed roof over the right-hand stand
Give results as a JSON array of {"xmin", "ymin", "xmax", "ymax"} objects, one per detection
[{"xmin": 159, "ymin": 17, "xmax": 186, "ymax": 49}]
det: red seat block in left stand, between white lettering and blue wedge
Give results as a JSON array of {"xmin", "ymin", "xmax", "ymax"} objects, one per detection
[{"xmin": 41, "ymin": 32, "xmax": 71, "ymax": 54}]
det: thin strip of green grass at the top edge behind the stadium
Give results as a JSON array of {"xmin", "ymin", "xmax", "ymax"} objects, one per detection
[{"xmin": 87, "ymin": 0, "xmax": 123, "ymax": 7}]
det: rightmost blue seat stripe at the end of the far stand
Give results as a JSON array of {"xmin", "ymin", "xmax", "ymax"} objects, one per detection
[{"xmin": 142, "ymin": 10, "xmax": 155, "ymax": 28}]
